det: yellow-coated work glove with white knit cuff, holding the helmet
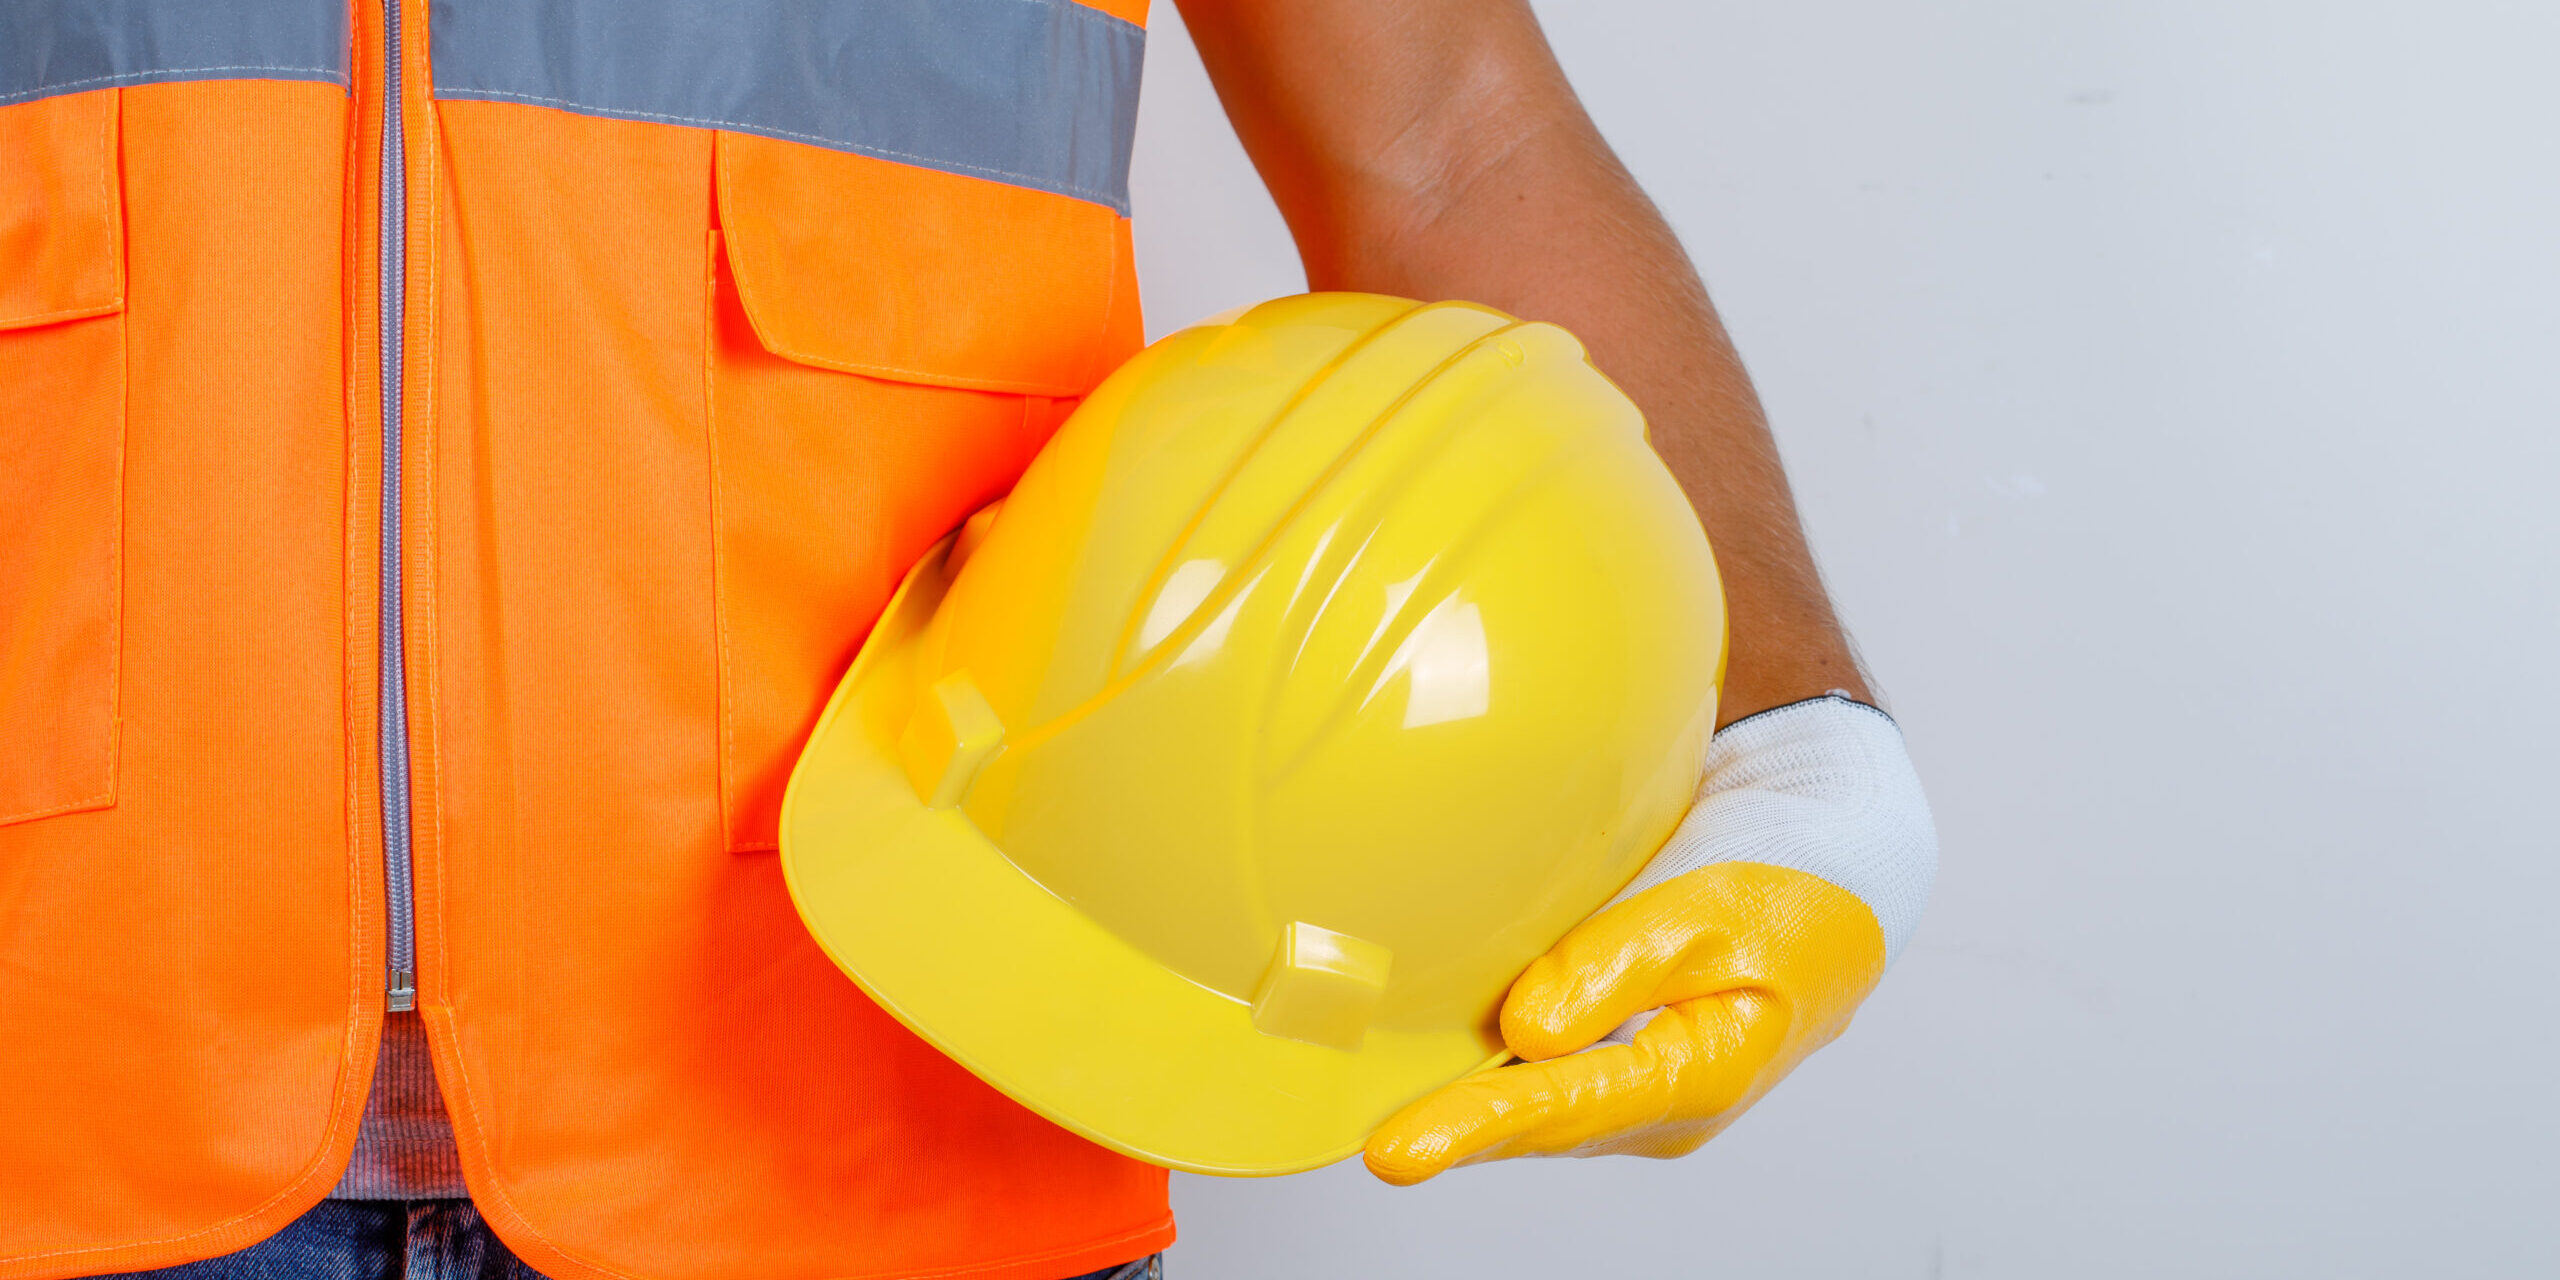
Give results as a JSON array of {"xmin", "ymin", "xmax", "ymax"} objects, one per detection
[{"xmin": 1367, "ymin": 699, "xmax": 1935, "ymax": 1185}]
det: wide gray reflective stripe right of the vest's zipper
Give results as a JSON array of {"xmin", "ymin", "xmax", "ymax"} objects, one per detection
[{"xmin": 433, "ymin": 0, "xmax": 1147, "ymax": 212}]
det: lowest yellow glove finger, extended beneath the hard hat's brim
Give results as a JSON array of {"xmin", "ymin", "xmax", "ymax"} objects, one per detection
[{"xmin": 1362, "ymin": 1044, "xmax": 1661, "ymax": 1185}]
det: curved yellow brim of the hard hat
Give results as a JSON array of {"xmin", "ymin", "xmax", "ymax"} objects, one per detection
[{"xmin": 781, "ymin": 543, "xmax": 1508, "ymax": 1175}]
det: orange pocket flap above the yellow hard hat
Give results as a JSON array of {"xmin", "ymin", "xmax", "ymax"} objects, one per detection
[{"xmin": 719, "ymin": 133, "xmax": 1137, "ymax": 397}]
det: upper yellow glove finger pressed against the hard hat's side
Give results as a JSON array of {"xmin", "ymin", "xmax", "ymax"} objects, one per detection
[{"xmin": 1503, "ymin": 868, "xmax": 1725, "ymax": 1062}]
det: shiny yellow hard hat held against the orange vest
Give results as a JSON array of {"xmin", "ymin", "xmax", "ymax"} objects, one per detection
[{"xmin": 781, "ymin": 294, "xmax": 1725, "ymax": 1175}]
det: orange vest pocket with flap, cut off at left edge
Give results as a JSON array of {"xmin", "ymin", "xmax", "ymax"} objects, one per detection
[{"xmin": 0, "ymin": 90, "xmax": 125, "ymax": 824}]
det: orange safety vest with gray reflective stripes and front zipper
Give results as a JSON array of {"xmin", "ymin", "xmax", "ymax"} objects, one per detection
[{"xmin": 0, "ymin": 0, "xmax": 1172, "ymax": 1280}]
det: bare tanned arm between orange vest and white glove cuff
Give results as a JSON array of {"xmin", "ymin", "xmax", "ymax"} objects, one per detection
[{"xmin": 1185, "ymin": 0, "xmax": 1866, "ymax": 719}]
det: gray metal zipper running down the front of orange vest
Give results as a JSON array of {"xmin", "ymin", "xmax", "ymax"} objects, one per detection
[{"xmin": 376, "ymin": 0, "xmax": 417, "ymax": 1014}]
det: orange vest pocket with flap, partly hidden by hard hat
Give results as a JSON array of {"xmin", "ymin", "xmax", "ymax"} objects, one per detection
[{"xmin": 707, "ymin": 133, "xmax": 1139, "ymax": 850}]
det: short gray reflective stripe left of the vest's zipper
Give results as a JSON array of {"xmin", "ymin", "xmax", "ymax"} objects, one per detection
[{"xmin": 0, "ymin": 0, "xmax": 348, "ymax": 105}]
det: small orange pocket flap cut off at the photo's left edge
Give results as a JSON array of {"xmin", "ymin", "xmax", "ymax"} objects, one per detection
[{"xmin": 0, "ymin": 90, "xmax": 125, "ymax": 330}]
